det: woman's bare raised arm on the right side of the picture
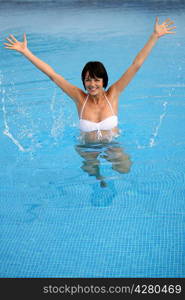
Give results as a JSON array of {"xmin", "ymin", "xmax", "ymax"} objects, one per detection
[{"xmin": 110, "ymin": 17, "xmax": 176, "ymax": 94}]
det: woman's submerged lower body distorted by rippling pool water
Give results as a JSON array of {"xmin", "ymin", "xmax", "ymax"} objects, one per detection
[{"xmin": 75, "ymin": 142, "xmax": 132, "ymax": 187}]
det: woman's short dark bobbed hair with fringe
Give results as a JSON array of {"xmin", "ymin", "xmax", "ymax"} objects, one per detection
[{"xmin": 81, "ymin": 61, "xmax": 108, "ymax": 89}]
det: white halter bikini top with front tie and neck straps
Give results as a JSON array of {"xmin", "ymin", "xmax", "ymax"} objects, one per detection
[{"xmin": 79, "ymin": 95, "xmax": 118, "ymax": 138}]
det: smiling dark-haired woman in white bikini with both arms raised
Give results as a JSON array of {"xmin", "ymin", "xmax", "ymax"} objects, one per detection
[{"xmin": 4, "ymin": 17, "xmax": 176, "ymax": 185}]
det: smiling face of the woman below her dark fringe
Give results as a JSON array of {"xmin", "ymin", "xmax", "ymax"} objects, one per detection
[{"xmin": 84, "ymin": 72, "xmax": 103, "ymax": 96}]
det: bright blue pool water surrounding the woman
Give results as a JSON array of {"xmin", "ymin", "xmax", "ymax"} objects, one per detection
[{"xmin": 0, "ymin": 0, "xmax": 185, "ymax": 277}]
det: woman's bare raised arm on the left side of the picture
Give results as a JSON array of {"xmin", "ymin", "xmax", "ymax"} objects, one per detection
[{"xmin": 4, "ymin": 34, "xmax": 82, "ymax": 101}]
